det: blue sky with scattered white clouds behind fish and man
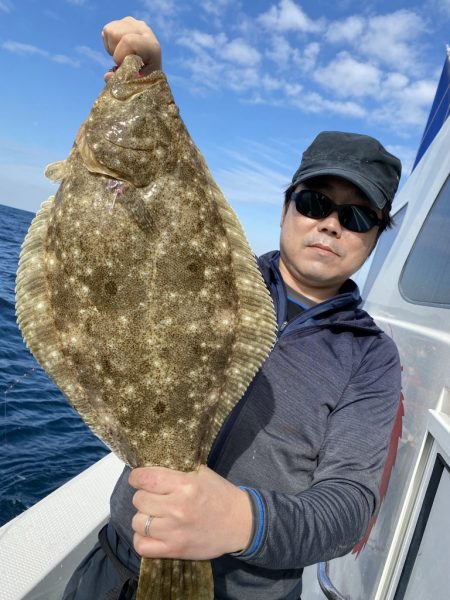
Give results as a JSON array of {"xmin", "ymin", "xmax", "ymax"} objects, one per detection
[{"xmin": 0, "ymin": 0, "xmax": 450, "ymax": 253}]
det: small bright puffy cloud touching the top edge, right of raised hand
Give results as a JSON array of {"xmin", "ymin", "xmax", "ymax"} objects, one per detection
[{"xmin": 258, "ymin": 0, "xmax": 324, "ymax": 33}]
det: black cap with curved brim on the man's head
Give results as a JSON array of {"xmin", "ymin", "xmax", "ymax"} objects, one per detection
[{"xmin": 292, "ymin": 131, "xmax": 402, "ymax": 209}]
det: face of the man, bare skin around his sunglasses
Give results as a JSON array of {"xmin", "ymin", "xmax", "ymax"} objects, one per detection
[{"xmin": 280, "ymin": 176, "xmax": 381, "ymax": 301}]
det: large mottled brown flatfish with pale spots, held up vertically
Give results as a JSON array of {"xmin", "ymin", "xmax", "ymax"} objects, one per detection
[{"xmin": 16, "ymin": 56, "xmax": 275, "ymax": 600}]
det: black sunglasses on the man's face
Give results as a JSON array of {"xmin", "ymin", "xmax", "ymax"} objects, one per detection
[{"xmin": 291, "ymin": 190, "xmax": 382, "ymax": 233}]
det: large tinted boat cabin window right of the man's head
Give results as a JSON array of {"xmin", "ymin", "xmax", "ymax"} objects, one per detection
[{"xmin": 400, "ymin": 173, "xmax": 450, "ymax": 308}]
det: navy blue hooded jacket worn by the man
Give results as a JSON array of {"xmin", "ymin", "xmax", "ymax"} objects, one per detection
[{"xmin": 111, "ymin": 252, "xmax": 400, "ymax": 600}]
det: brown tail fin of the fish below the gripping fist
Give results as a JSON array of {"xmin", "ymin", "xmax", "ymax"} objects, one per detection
[{"xmin": 136, "ymin": 558, "xmax": 214, "ymax": 600}]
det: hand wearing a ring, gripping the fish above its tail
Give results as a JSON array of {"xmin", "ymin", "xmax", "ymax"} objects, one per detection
[{"xmin": 128, "ymin": 466, "xmax": 253, "ymax": 560}]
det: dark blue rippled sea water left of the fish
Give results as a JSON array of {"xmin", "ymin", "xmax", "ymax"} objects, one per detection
[{"xmin": 0, "ymin": 205, "xmax": 108, "ymax": 525}]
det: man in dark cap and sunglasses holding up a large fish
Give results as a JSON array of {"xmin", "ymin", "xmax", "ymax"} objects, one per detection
[{"xmin": 65, "ymin": 17, "xmax": 401, "ymax": 600}]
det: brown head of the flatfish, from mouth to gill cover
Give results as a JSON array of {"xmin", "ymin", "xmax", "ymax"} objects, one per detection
[{"xmin": 76, "ymin": 55, "xmax": 179, "ymax": 187}]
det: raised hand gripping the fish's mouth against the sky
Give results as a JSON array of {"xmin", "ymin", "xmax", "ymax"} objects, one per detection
[{"xmin": 102, "ymin": 17, "xmax": 161, "ymax": 81}]
